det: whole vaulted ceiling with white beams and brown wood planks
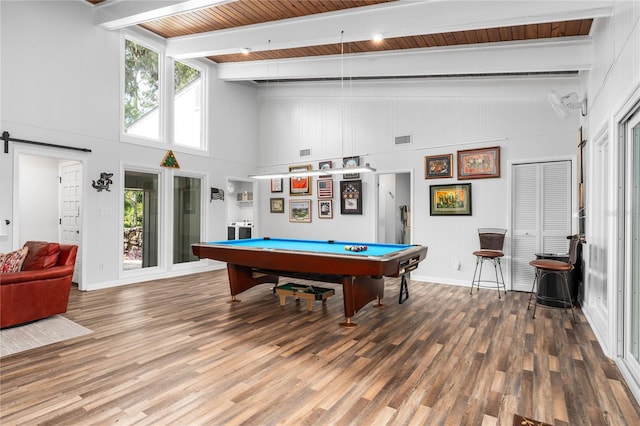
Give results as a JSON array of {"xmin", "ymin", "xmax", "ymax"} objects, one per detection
[{"xmin": 87, "ymin": 0, "xmax": 613, "ymax": 81}]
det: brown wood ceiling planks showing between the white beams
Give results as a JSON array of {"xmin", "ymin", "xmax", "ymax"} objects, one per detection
[{"xmin": 87, "ymin": 0, "xmax": 593, "ymax": 63}]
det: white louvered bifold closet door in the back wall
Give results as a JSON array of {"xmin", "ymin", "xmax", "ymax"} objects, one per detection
[{"xmin": 511, "ymin": 161, "xmax": 571, "ymax": 291}]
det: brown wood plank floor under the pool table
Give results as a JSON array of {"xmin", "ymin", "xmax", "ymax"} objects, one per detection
[{"xmin": 0, "ymin": 271, "xmax": 640, "ymax": 426}]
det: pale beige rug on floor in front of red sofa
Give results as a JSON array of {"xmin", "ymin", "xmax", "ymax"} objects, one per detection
[{"xmin": 0, "ymin": 315, "xmax": 92, "ymax": 357}]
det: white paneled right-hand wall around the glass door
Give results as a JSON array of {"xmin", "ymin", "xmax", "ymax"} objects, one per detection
[{"xmin": 581, "ymin": 0, "xmax": 640, "ymax": 400}]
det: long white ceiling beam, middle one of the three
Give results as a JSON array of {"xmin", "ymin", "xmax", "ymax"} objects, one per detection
[{"xmin": 167, "ymin": 0, "xmax": 613, "ymax": 59}]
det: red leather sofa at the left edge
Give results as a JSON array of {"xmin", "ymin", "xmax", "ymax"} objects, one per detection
[{"xmin": 0, "ymin": 241, "xmax": 78, "ymax": 328}]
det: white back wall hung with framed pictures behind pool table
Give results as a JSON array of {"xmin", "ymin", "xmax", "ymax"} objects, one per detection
[{"xmin": 258, "ymin": 77, "xmax": 580, "ymax": 285}]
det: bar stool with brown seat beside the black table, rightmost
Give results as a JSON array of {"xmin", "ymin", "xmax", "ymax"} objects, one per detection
[{"xmin": 527, "ymin": 235, "xmax": 580, "ymax": 323}]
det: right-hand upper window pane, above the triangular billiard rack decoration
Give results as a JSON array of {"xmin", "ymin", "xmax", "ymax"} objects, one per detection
[{"xmin": 173, "ymin": 61, "xmax": 203, "ymax": 148}]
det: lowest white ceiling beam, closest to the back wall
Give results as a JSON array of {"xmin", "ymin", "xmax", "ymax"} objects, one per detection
[{"xmin": 216, "ymin": 37, "xmax": 592, "ymax": 81}]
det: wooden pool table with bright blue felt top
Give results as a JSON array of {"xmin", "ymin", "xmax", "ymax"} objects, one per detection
[{"xmin": 191, "ymin": 238, "xmax": 427, "ymax": 326}]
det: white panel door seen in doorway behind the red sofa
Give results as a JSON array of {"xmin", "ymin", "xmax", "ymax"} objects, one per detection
[{"xmin": 60, "ymin": 162, "xmax": 82, "ymax": 286}]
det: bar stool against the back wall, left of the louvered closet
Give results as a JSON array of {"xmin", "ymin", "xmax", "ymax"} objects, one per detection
[{"xmin": 469, "ymin": 228, "xmax": 507, "ymax": 299}]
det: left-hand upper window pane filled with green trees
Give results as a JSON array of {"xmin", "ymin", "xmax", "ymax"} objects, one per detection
[{"xmin": 124, "ymin": 39, "xmax": 160, "ymax": 139}]
